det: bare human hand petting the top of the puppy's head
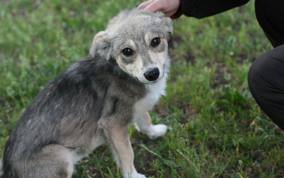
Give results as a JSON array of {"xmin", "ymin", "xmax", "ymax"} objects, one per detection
[{"xmin": 138, "ymin": 0, "xmax": 180, "ymax": 17}]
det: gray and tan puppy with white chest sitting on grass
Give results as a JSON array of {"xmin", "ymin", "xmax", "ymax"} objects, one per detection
[{"xmin": 2, "ymin": 10, "xmax": 173, "ymax": 178}]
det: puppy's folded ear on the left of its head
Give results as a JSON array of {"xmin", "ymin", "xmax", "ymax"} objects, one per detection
[{"xmin": 90, "ymin": 31, "xmax": 111, "ymax": 60}]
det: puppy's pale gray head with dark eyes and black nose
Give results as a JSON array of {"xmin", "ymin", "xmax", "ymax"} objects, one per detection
[{"xmin": 90, "ymin": 10, "xmax": 173, "ymax": 84}]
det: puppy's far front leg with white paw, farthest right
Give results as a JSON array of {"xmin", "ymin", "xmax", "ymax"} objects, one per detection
[{"xmin": 135, "ymin": 112, "xmax": 167, "ymax": 139}]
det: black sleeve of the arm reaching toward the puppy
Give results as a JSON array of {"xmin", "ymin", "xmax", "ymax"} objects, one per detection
[{"xmin": 174, "ymin": 0, "xmax": 249, "ymax": 18}]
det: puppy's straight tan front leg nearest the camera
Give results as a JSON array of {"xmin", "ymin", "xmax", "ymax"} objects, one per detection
[{"xmin": 101, "ymin": 121, "xmax": 146, "ymax": 178}]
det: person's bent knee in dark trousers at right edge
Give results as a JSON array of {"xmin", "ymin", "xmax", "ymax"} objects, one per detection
[{"xmin": 248, "ymin": 45, "xmax": 284, "ymax": 130}]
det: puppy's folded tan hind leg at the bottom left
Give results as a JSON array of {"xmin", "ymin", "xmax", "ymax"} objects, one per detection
[{"xmin": 16, "ymin": 144, "xmax": 74, "ymax": 178}]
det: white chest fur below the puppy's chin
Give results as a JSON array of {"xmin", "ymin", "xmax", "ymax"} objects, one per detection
[{"xmin": 134, "ymin": 77, "xmax": 166, "ymax": 117}]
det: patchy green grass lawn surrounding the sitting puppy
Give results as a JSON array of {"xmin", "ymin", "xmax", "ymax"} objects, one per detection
[{"xmin": 0, "ymin": 0, "xmax": 284, "ymax": 178}]
